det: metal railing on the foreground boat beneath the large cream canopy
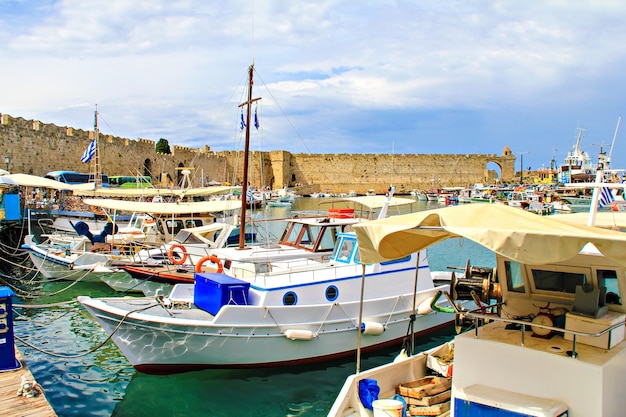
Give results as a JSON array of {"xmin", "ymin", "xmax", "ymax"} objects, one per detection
[{"xmin": 462, "ymin": 303, "xmax": 626, "ymax": 358}]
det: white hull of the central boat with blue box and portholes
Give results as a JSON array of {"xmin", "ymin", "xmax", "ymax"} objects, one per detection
[{"xmin": 79, "ymin": 291, "xmax": 454, "ymax": 373}]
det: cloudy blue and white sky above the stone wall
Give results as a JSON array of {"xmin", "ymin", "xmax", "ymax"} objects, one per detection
[{"xmin": 0, "ymin": 0, "xmax": 626, "ymax": 169}]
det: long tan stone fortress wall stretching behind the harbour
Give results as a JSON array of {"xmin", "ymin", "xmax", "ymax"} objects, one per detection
[{"xmin": 0, "ymin": 114, "xmax": 515, "ymax": 194}]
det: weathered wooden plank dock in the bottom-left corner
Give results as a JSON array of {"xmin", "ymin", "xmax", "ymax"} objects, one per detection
[{"xmin": 0, "ymin": 349, "xmax": 57, "ymax": 417}]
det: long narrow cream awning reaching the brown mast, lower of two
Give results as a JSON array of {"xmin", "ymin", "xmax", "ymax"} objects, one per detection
[{"xmin": 83, "ymin": 198, "xmax": 241, "ymax": 214}]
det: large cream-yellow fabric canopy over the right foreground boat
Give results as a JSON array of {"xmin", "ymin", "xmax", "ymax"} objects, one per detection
[{"xmin": 354, "ymin": 204, "xmax": 626, "ymax": 265}]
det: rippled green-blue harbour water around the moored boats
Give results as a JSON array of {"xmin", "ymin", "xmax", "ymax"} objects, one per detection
[{"xmin": 9, "ymin": 198, "xmax": 494, "ymax": 417}]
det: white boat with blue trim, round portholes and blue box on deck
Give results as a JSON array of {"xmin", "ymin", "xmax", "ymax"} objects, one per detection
[{"xmin": 78, "ymin": 234, "xmax": 454, "ymax": 373}]
